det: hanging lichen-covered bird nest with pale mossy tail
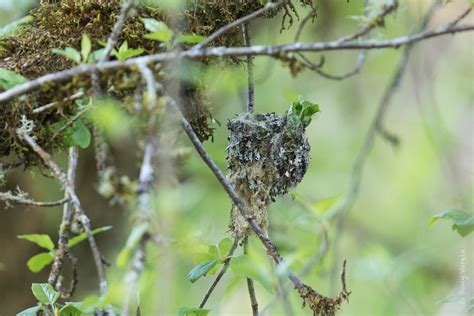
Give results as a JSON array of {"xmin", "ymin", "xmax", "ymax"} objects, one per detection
[{"xmin": 227, "ymin": 113, "xmax": 311, "ymax": 238}]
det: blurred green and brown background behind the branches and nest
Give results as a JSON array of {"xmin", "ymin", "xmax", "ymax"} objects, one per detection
[{"xmin": 0, "ymin": 0, "xmax": 474, "ymax": 316}]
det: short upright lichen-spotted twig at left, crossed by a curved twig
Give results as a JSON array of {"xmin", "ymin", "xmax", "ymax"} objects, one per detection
[{"xmin": 48, "ymin": 147, "xmax": 78, "ymax": 291}]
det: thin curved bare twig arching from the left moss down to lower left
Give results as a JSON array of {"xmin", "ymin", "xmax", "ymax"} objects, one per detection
[{"xmin": 17, "ymin": 131, "xmax": 107, "ymax": 296}]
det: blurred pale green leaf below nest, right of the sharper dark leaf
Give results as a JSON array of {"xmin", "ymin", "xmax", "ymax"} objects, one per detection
[{"xmin": 230, "ymin": 255, "xmax": 272, "ymax": 293}]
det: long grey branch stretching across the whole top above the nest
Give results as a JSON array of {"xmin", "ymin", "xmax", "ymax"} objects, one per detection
[{"xmin": 0, "ymin": 24, "xmax": 474, "ymax": 104}]
